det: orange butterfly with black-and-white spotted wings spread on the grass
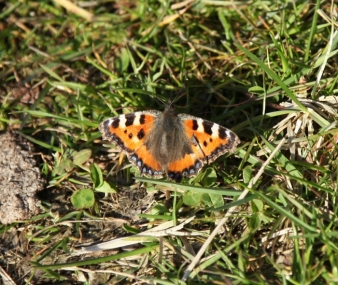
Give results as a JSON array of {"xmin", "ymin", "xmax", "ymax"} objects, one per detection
[{"xmin": 99, "ymin": 105, "xmax": 240, "ymax": 182}]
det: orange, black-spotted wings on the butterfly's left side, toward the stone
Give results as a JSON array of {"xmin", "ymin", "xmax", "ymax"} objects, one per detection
[{"xmin": 99, "ymin": 111, "xmax": 163, "ymax": 177}]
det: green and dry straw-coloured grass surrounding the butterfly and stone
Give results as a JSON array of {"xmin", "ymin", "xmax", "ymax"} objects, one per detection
[{"xmin": 0, "ymin": 0, "xmax": 338, "ymax": 284}]
